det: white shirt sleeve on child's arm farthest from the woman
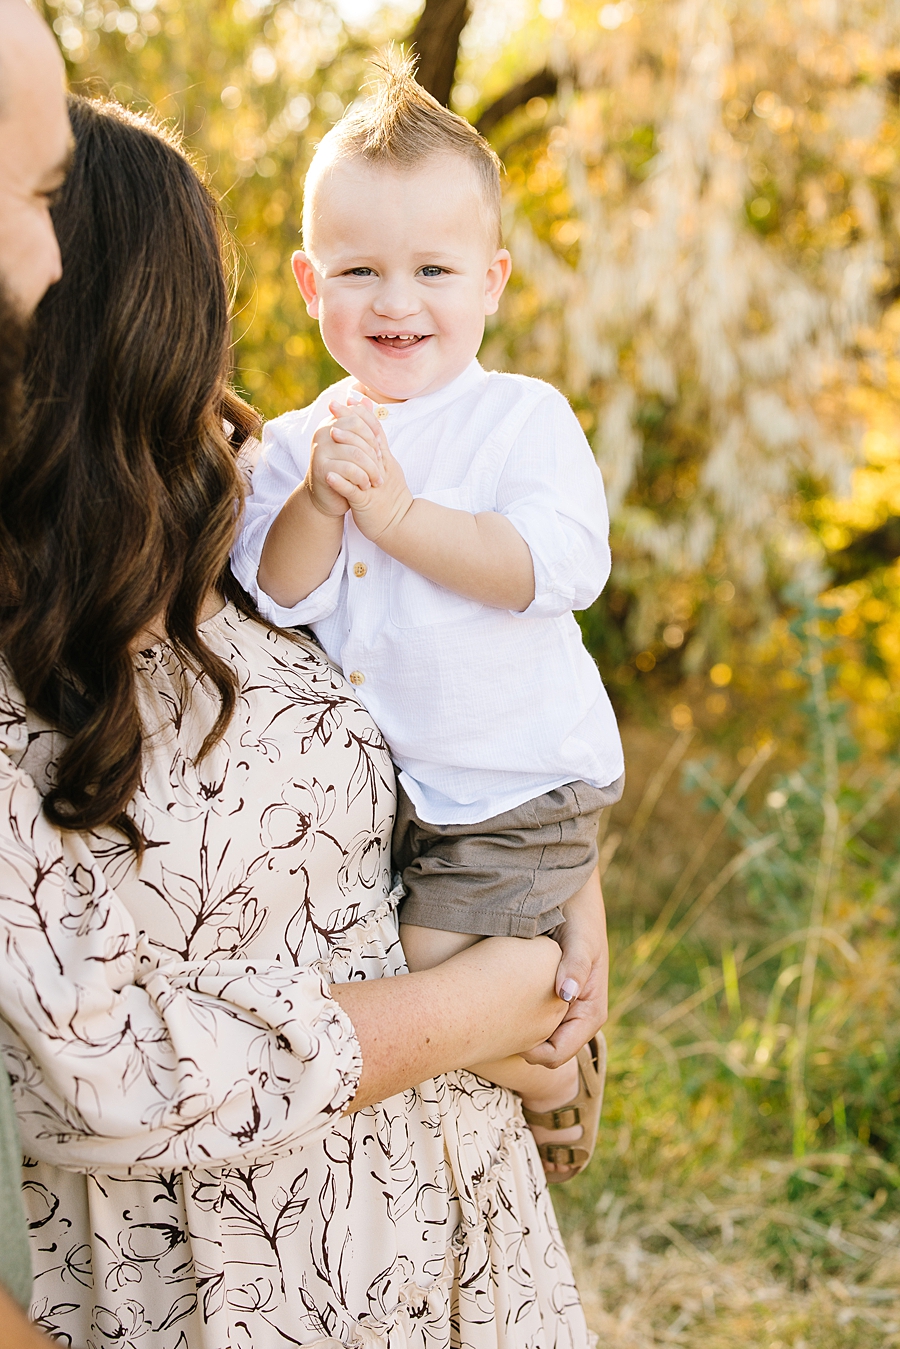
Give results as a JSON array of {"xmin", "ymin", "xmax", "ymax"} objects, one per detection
[{"xmin": 497, "ymin": 390, "xmax": 610, "ymax": 618}]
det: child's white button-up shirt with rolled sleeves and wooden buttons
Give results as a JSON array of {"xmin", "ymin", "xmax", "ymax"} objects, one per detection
[{"xmin": 232, "ymin": 362, "xmax": 623, "ymax": 824}]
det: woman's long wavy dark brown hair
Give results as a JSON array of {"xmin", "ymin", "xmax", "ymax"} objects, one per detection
[{"xmin": 0, "ymin": 97, "xmax": 265, "ymax": 853}]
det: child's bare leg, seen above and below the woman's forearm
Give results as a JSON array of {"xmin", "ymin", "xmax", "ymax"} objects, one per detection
[{"xmin": 399, "ymin": 923, "xmax": 583, "ymax": 1171}]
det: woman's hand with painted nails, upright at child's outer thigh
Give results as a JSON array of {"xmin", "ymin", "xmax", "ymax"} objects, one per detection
[{"xmin": 522, "ymin": 871, "xmax": 610, "ymax": 1068}]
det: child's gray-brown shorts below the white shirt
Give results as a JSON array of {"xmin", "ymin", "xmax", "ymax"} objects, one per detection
[{"xmin": 393, "ymin": 774, "xmax": 625, "ymax": 936}]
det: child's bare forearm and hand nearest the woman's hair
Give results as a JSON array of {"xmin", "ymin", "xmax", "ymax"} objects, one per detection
[{"xmin": 256, "ymin": 403, "xmax": 383, "ymax": 608}]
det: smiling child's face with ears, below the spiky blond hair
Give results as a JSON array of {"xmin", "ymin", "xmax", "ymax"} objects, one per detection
[{"xmin": 293, "ymin": 154, "xmax": 510, "ymax": 402}]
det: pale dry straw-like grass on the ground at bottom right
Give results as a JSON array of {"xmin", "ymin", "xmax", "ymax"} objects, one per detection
[{"xmin": 565, "ymin": 1155, "xmax": 900, "ymax": 1349}]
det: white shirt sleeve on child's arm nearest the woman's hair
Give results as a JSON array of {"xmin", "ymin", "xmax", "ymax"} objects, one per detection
[{"xmin": 231, "ymin": 403, "xmax": 345, "ymax": 627}]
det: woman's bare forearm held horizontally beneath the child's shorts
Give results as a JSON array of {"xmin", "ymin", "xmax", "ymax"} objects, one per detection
[{"xmin": 332, "ymin": 938, "xmax": 568, "ymax": 1113}]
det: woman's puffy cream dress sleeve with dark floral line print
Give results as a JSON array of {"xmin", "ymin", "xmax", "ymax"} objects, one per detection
[{"xmin": 0, "ymin": 751, "xmax": 362, "ymax": 1175}]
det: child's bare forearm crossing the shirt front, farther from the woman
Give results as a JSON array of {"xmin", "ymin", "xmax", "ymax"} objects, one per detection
[{"xmin": 328, "ymin": 405, "xmax": 534, "ymax": 611}]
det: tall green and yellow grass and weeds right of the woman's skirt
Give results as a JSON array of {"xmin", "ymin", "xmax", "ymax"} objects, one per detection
[{"xmin": 557, "ymin": 611, "xmax": 900, "ymax": 1349}]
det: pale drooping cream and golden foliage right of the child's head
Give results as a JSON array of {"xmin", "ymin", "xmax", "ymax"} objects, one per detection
[{"xmin": 472, "ymin": 0, "xmax": 900, "ymax": 700}]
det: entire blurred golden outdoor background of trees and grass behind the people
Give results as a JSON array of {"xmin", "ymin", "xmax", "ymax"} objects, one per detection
[{"xmin": 43, "ymin": 0, "xmax": 900, "ymax": 1349}]
